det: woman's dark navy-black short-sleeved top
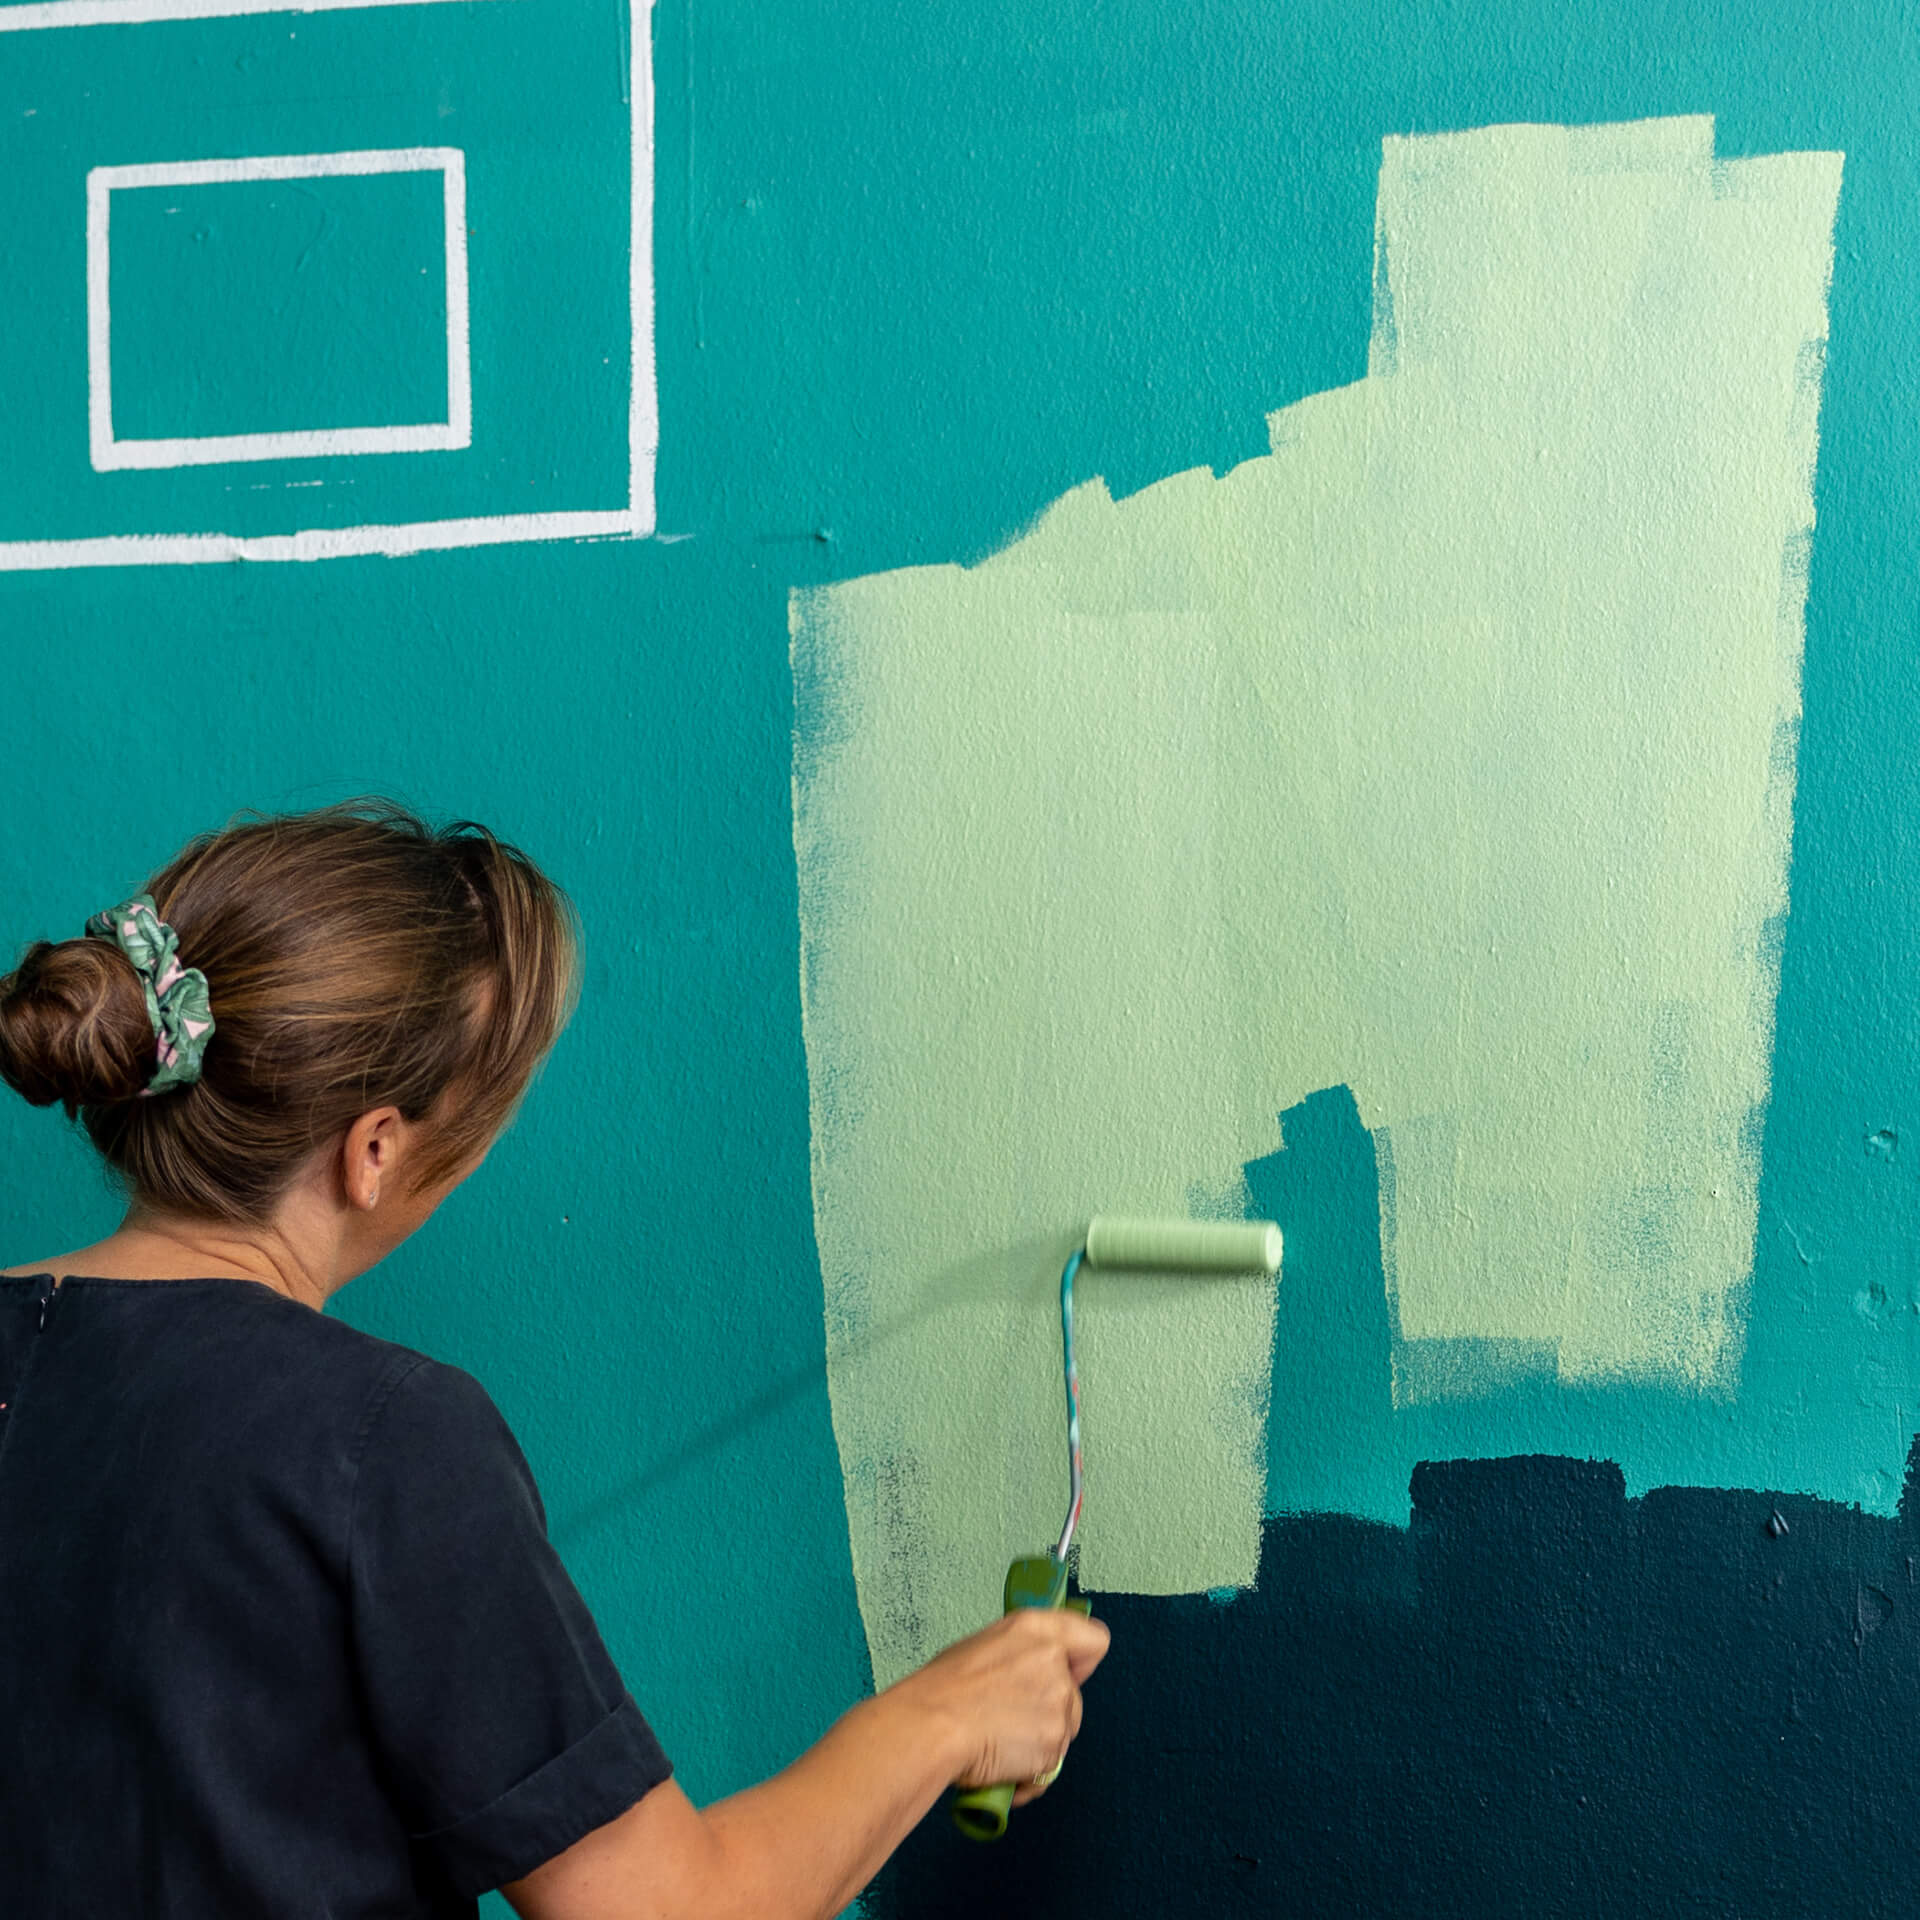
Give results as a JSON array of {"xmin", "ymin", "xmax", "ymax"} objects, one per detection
[{"xmin": 0, "ymin": 1277, "xmax": 670, "ymax": 1920}]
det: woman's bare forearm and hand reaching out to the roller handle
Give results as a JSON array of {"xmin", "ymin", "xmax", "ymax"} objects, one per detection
[{"xmin": 501, "ymin": 1609, "xmax": 1108, "ymax": 1920}]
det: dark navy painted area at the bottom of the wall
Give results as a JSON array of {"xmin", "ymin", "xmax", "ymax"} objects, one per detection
[{"xmin": 872, "ymin": 1455, "xmax": 1920, "ymax": 1920}]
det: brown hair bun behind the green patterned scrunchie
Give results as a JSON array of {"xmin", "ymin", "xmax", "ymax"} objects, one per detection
[{"xmin": 0, "ymin": 939, "xmax": 154, "ymax": 1114}]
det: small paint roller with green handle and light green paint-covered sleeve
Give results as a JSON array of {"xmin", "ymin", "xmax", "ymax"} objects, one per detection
[{"xmin": 952, "ymin": 1213, "xmax": 1281, "ymax": 1839}]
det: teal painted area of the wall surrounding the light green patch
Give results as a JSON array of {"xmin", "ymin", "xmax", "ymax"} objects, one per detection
[{"xmin": 11, "ymin": 0, "xmax": 1920, "ymax": 1896}]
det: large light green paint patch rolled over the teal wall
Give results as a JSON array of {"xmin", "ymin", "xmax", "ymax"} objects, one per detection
[{"xmin": 793, "ymin": 119, "xmax": 1839, "ymax": 1682}]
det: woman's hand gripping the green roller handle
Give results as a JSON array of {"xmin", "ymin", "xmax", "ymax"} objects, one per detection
[{"xmin": 889, "ymin": 1607, "xmax": 1110, "ymax": 1807}]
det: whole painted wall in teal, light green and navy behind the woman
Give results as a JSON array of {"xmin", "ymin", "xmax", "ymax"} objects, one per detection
[{"xmin": 11, "ymin": 0, "xmax": 1920, "ymax": 1914}]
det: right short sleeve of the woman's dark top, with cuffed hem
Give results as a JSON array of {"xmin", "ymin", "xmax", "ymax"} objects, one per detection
[{"xmin": 348, "ymin": 1359, "xmax": 672, "ymax": 1895}]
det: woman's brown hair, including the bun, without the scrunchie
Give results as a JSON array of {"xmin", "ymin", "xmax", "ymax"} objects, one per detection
[{"xmin": 0, "ymin": 801, "xmax": 580, "ymax": 1225}]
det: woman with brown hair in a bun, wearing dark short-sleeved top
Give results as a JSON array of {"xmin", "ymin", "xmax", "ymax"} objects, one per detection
[{"xmin": 0, "ymin": 804, "xmax": 1106, "ymax": 1920}]
